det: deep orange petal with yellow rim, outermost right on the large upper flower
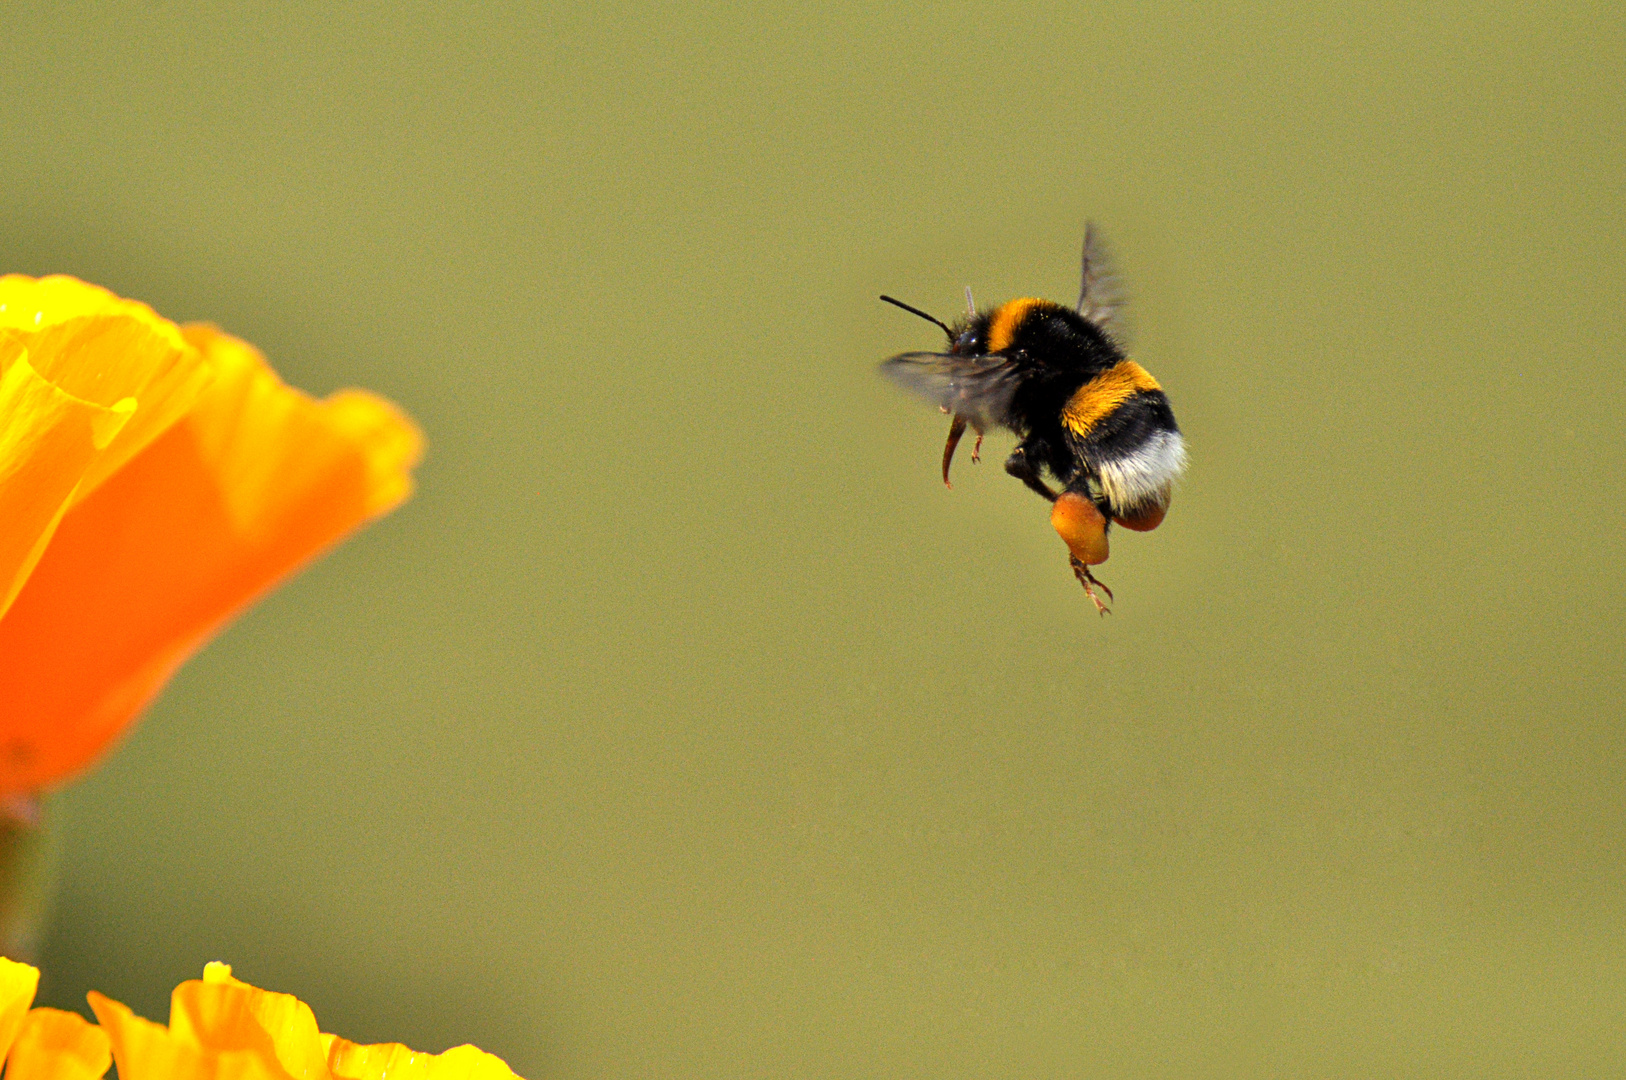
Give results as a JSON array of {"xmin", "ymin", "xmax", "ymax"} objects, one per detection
[{"xmin": 0, "ymin": 325, "xmax": 423, "ymax": 792}]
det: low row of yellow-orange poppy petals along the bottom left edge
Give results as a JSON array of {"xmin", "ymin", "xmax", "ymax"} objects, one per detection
[{"xmin": 0, "ymin": 960, "xmax": 514, "ymax": 1080}]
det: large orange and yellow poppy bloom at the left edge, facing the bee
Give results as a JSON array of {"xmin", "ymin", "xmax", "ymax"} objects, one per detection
[{"xmin": 0, "ymin": 275, "xmax": 423, "ymax": 794}]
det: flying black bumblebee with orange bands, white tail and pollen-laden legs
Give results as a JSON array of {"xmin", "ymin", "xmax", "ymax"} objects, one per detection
[{"xmin": 881, "ymin": 224, "xmax": 1185, "ymax": 615}]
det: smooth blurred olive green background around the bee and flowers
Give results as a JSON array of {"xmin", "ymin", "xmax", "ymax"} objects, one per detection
[{"xmin": 0, "ymin": 2, "xmax": 1626, "ymax": 1080}]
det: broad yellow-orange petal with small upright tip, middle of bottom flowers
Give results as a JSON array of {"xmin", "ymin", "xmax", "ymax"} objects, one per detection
[{"xmin": 169, "ymin": 965, "xmax": 328, "ymax": 1080}]
